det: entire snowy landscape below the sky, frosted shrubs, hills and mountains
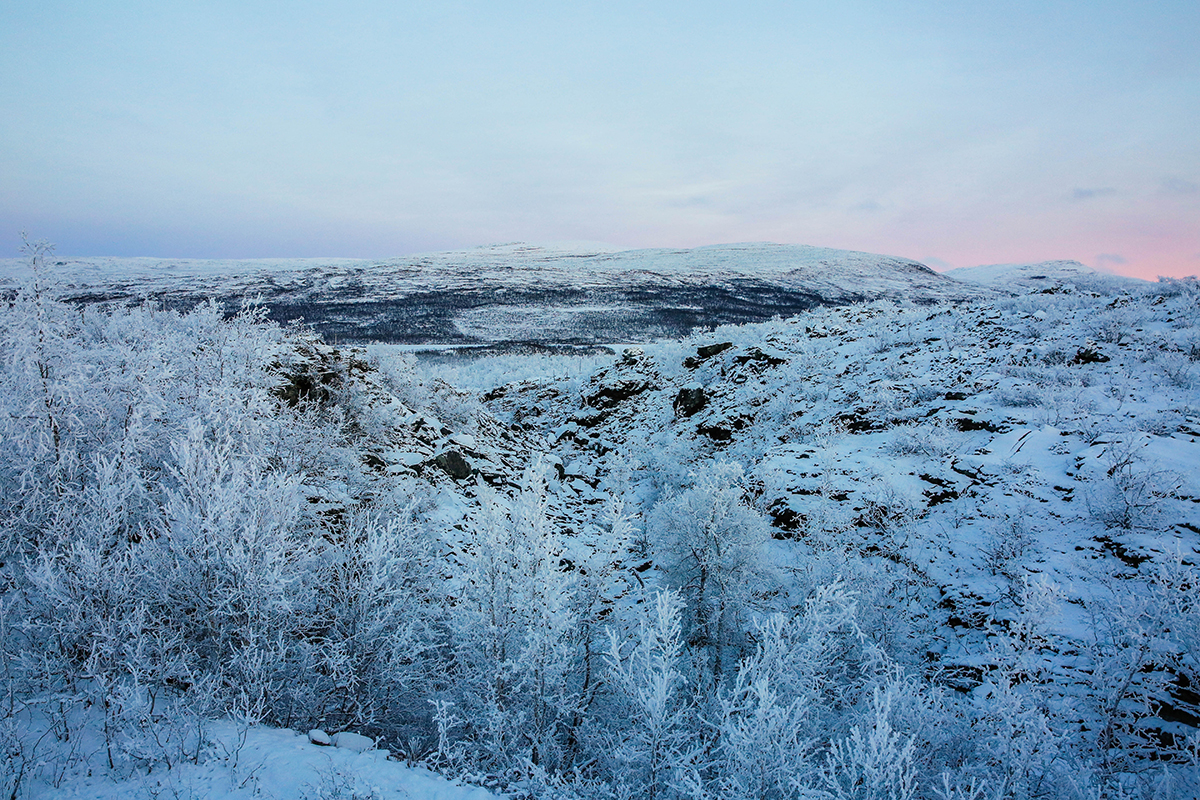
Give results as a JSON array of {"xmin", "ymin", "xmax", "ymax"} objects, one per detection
[{"xmin": 0, "ymin": 245, "xmax": 1200, "ymax": 800}]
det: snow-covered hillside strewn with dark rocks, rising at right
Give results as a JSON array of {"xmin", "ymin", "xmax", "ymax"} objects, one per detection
[{"xmin": 477, "ymin": 269, "xmax": 1200, "ymax": 786}]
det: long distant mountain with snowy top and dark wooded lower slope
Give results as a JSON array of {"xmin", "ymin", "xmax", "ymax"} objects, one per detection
[{"xmin": 0, "ymin": 243, "xmax": 988, "ymax": 345}]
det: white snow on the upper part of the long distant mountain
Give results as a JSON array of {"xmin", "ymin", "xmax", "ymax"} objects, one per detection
[{"xmin": 0, "ymin": 242, "xmax": 979, "ymax": 309}]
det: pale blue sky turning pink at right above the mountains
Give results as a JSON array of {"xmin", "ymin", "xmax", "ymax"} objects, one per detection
[{"xmin": 0, "ymin": 0, "xmax": 1200, "ymax": 279}]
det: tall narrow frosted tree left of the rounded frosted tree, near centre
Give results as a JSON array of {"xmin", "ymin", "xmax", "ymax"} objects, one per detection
[{"xmin": 450, "ymin": 464, "xmax": 578, "ymax": 770}]
